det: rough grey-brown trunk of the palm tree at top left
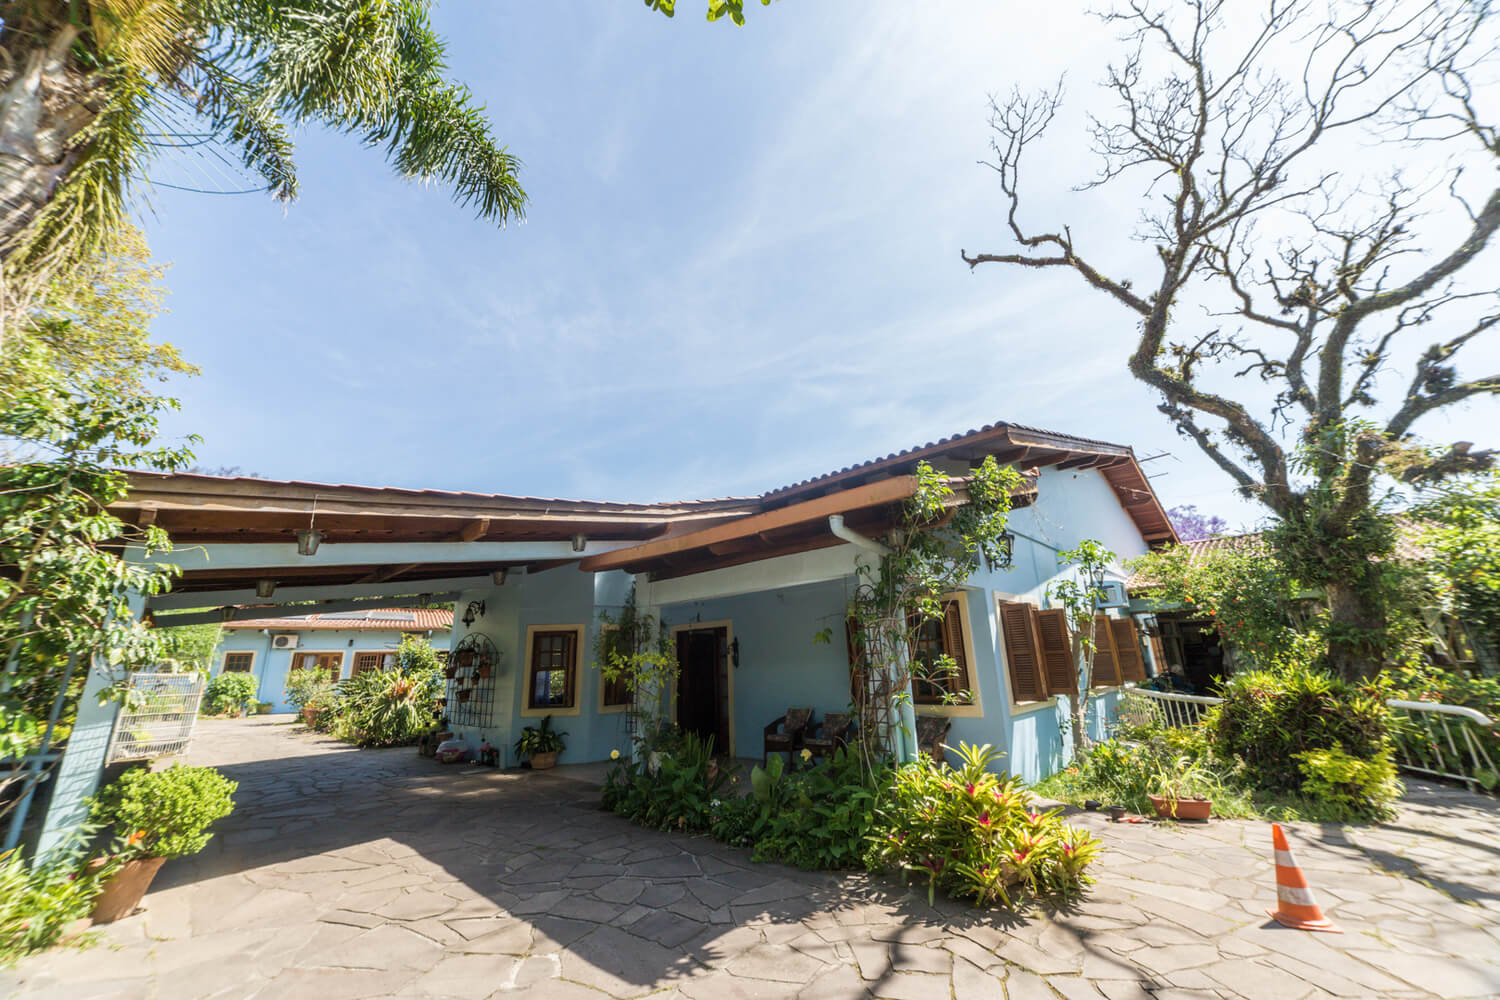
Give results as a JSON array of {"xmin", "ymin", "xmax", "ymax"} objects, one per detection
[{"xmin": 0, "ymin": 25, "xmax": 99, "ymax": 259}]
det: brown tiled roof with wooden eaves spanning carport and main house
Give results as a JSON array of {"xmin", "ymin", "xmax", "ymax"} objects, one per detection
[{"xmin": 111, "ymin": 421, "xmax": 1176, "ymax": 602}]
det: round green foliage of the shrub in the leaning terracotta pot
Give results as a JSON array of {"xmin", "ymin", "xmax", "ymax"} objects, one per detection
[{"xmin": 93, "ymin": 765, "xmax": 239, "ymax": 858}]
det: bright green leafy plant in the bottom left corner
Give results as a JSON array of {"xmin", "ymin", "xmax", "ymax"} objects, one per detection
[{"xmin": 0, "ymin": 850, "xmax": 113, "ymax": 969}]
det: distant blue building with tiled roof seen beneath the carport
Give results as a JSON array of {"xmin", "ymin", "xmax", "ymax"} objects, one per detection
[{"xmin": 213, "ymin": 607, "xmax": 453, "ymax": 712}]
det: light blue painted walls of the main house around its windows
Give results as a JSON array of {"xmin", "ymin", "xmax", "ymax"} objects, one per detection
[{"xmin": 438, "ymin": 469, "xmax": 1146, "ymax": 781}]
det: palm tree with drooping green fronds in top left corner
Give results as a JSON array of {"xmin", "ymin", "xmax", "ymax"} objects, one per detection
[{"xmin": 0, "ymin": 0, "xmax": 527, "ymax": 316}]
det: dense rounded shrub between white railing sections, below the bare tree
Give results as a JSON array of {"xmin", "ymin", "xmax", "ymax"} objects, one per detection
[{"xmin": 1205, "ymin": 663, "xmax": 1392, "ymax": 792}]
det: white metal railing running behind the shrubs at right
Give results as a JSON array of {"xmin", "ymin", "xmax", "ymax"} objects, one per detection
[{"xmin": 1121, "ymin": 688, "xmax": 1500, "ymax": 792}]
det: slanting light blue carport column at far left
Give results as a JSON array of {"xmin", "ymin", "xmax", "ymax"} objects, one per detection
[{"xmin": 36, "ymin": 592, "xmax": 146, "ymax": 858}]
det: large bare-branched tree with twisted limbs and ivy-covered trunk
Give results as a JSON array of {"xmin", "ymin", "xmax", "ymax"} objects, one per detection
[{"xmin": 962, "ymin": 0, "xmax": 1500, "ymax": 678}]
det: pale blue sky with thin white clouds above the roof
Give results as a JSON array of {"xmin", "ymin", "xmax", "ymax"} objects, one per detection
[{"xmin": 140, "ymin": 0, "xmax": 1500, "ymax": 536}]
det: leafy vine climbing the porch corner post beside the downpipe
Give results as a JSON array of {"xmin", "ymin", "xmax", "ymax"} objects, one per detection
[{"xmin": 819, "ymin": 456, "xmax": 1022, "ymax": 766}]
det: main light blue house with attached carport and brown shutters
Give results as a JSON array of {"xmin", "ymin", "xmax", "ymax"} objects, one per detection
[{"xmin": 123, "ymin": 423, "xmax": 1176, "ymax": 780}]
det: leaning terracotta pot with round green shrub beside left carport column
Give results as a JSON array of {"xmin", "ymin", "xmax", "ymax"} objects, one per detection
[{"xmin": 92, "ymin": 765, "xmax": 239, "ymax": 924}]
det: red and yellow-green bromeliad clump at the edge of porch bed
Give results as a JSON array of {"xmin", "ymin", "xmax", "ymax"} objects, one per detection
[{"xmin": 869, "ymin": 744, "xmax": 1103, "ymax": 907}]
